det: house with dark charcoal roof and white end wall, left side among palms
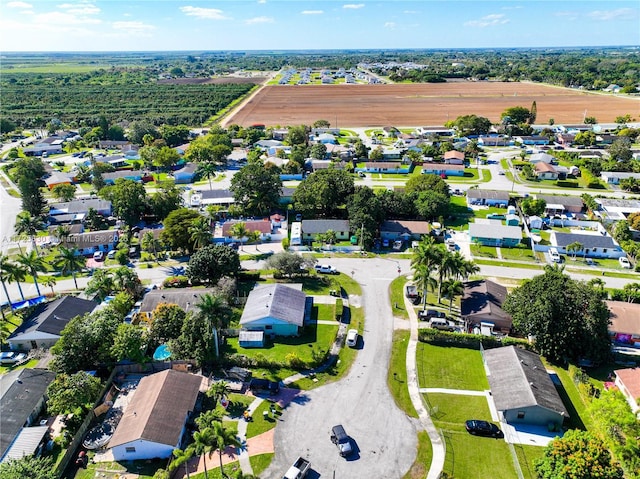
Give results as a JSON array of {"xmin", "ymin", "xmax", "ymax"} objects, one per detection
[{"xmin": 7, "ymin": 296, "xmax": 98, "ymax": 350}]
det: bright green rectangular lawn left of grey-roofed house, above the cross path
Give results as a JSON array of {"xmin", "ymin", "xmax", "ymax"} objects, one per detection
[{"xmin": 416, "ymin": 343, "xmax": 489, "ymax": 391}]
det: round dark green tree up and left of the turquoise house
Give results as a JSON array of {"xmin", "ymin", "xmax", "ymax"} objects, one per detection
[{"xmin": 186, "ymin": 244, "xmax": 240, "ymax": 284}]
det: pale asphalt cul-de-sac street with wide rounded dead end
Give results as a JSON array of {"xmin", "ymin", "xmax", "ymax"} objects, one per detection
[{"xmin": 261, "ymin": 258, "xmax": 417, "ymax": 479}]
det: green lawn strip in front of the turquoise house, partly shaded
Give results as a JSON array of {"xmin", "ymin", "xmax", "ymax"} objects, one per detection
[{"xmin": 225, "ymin": 323, "xmax": 338, "ymax": 363}]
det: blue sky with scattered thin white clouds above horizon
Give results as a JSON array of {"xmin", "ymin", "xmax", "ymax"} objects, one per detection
[{"xmin": 0, "ymin": 0, "xmax": 640, "ymax": 52}]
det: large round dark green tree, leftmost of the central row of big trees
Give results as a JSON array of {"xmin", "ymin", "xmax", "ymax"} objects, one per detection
[{"xmin": 230, "ymin": 163, "xmax": 282, "ymax": 216}]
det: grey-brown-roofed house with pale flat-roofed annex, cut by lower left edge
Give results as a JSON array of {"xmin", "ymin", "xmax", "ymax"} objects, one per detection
[{"xmin": 0, "ymin": 369, "xmax": 56, "ymax": 462}]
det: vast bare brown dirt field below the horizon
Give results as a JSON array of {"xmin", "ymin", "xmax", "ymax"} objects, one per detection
[{"xmin": 224, "ymin": 82, "xmax": 640, "ymax": 127}]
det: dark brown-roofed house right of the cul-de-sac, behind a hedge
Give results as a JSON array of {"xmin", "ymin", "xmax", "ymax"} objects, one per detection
[{"xmin": 460, "ymin": 279, "xmax": 513, "ymax": 334}]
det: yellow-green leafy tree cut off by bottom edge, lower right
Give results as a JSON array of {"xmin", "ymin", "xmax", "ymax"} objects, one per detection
[{"xmin": 535, "ymin": 429, "xmax": 624, "ymax": 479}]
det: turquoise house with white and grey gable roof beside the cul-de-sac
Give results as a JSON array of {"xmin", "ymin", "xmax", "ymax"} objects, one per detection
[{"xmin": 240, "ymin": 283, "xmax": 312, "ymax": 336}]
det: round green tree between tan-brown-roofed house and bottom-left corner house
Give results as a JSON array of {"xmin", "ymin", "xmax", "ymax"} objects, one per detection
[{"xmin": 47, "ymin": 371, "xmax": 102, "ymax": 415}]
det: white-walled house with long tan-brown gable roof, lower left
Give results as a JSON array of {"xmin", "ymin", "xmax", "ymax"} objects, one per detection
[{"xmin": 107, "ymin": 369, "xmax": 203, "ymax": 461}]
